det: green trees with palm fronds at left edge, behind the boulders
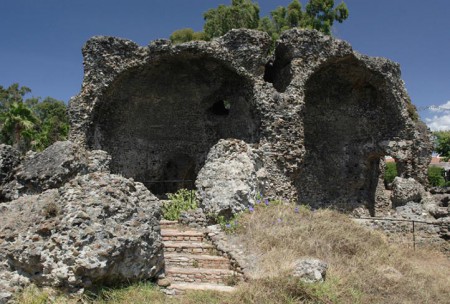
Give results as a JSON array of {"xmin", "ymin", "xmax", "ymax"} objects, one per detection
[{"xmin": 0, "ymin": 83, "xmax": 69, "ymax": 152}]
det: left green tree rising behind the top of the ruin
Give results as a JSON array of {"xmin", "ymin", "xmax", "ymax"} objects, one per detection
[{"xmin": 203, "ymin": 0, "xmax": 259, "ymax": 39}]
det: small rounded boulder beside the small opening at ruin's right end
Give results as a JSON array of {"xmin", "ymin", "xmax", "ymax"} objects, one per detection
[{"xmin": 391, "ymin": 176, "xmax": 425, "ymax": 207}]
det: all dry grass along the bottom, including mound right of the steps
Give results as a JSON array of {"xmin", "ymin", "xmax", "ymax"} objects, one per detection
[{"xmin": 14, "ymin": 204, "xmax": 450, "ymax": 304}]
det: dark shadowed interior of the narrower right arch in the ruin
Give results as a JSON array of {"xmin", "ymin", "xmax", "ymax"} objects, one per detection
[{"xmin": 296, "ymin": 57, "xmax": 402, "ymax": 214}]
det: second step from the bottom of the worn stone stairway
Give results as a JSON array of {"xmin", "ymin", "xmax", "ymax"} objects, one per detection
[{"xmin": 165, "ymin": 266, "xmax": 234, "ymax": 285}]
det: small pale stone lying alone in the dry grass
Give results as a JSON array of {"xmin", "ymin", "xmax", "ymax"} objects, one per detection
[{"xmin": 293, "ymin": 258, "xmax": 328, "ymax": 283}]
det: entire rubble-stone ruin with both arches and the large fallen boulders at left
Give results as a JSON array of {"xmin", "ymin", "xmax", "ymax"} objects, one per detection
[{"xmin": 0, "ymin": 29, "xmax": 448, "ymax": 302}]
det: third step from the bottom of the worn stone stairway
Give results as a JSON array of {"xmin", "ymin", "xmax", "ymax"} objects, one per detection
[{"xmin": 164, "ymin": 252, "xmax": 231, "ymax": 269}]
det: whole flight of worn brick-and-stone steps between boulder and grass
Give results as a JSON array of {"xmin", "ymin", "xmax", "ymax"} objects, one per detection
[{"xmin": 160, "ymin": 220, "xmax": 238, "ymax": 294}]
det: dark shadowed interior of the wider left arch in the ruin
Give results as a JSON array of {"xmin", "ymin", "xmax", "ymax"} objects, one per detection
[{"xmin": 88, "ymin": 54, "xmax": 259, "ymax": 195}]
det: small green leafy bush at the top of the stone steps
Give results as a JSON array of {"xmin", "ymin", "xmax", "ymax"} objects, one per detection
[{"xmin": 162, "ymin": 189, "xmax": 198, "ymax": 221}]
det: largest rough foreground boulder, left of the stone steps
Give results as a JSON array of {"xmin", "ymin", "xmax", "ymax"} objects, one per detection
[{"xmin": 0, "ymin": 173, "xmax": 163, "ymax": 292}]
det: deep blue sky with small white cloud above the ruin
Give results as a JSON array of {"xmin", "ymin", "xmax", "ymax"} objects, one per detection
[{"xmin": 0, "ymin": 0, "xmax": 450, "ymax": 129}]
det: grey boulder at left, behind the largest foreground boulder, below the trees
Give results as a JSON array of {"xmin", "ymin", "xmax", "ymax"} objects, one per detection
[{"xmin": 0, "ymin": 141, "xmax": 111, "ymax": 201}]
